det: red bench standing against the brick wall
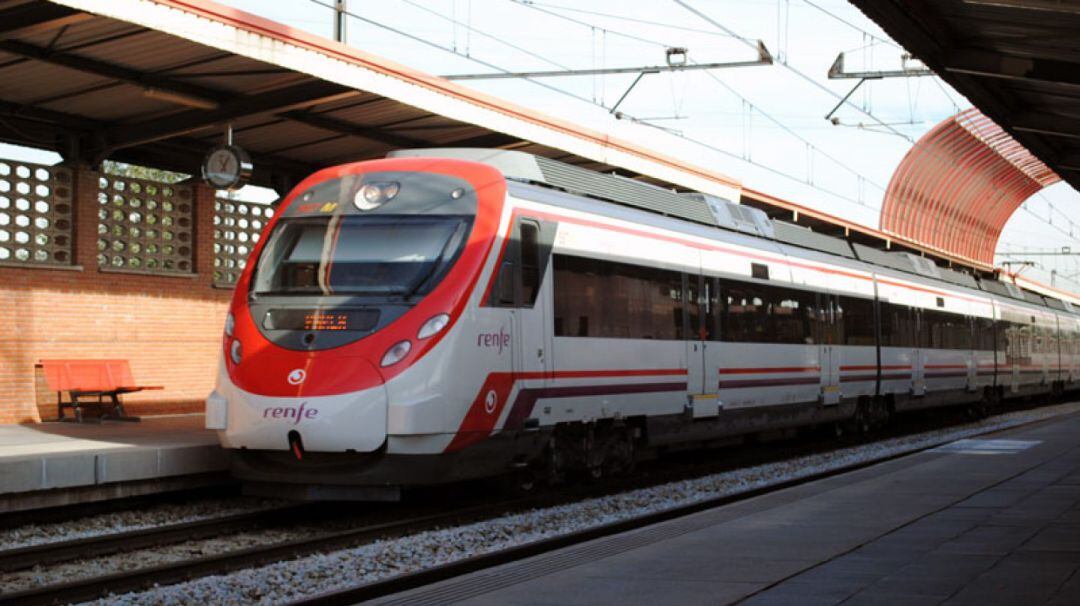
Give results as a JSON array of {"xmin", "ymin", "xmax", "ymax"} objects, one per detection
[{"xmin": 41, "ymin": 360, "xmax": 165, "ymax": 422}]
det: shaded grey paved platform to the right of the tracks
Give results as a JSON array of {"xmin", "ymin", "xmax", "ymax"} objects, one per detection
[{"xmin": 379, "ymin": 415, "xmax": 1080, "ymax": 606}]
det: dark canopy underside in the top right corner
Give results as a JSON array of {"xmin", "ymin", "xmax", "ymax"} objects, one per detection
[{"xmin": 851, "ymin": 0, "xmax": 1080, "ymax": 196}]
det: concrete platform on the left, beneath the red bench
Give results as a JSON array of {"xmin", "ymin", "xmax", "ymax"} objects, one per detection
[{"xmin": 0, "ymin": 415, "xmax": 228, "ymax": 513}]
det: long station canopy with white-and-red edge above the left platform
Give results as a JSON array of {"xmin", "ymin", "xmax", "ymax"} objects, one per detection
[{"xmin": 0, "ymin": 0, "xmax": 1071, "ymax": 287}]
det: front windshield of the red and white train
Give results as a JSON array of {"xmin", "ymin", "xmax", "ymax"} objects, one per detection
[{"xmin": 252, "ymin": 215, "xmax": 471, "ymax": 297}]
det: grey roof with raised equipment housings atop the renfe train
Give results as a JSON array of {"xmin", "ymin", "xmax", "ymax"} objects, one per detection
[{"xmin": 389, "ymin": 148, "xmax": 1080, "ymax": 313}]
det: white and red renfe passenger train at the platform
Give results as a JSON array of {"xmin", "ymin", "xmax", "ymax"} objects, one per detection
[{"xmin": 206, "ymin": 149, "xmax": 1080, "ymax": 500}]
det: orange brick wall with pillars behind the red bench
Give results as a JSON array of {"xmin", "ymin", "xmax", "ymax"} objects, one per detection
[{"xmin": 0, "ymin": 164, "xmax": 231, "ymax": 423}]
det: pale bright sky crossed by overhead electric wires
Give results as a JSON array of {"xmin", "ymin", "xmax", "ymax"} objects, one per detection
[{"xmin": 0, "ymin": 0, "xmax": 1080, "ymax": 291}]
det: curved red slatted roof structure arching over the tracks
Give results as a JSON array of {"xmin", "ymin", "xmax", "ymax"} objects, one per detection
[{"xmin": 881, "ymin": 108, "xmax": 1061, "ymax": 265}]
